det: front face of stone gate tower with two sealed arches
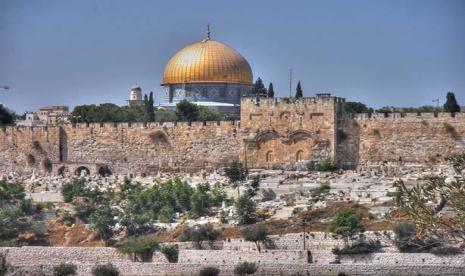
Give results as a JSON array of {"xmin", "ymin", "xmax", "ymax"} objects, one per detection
[{"xmin": 241, "ymin": 97, "xmax": 344, "ymax": 168}]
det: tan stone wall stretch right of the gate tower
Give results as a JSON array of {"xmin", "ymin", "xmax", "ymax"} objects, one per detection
[{"xmin": 352, "ymin": 113, "xmax": 465, "ymax": 169}]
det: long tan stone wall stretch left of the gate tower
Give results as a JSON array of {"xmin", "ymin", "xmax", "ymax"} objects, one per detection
[{"xmin": 0, "ymin": 122, "xmax": 240, "ymax": 175}]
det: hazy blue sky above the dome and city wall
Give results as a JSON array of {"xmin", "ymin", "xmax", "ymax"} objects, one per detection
[{"xmin": 0, "ymin": 0, "xmax": 465, "ymax": 112}]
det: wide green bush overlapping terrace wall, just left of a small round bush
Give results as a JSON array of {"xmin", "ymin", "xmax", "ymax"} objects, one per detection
[{"xmin": 118, "ymin": 236, "xmax": 160, "ymax": 262}]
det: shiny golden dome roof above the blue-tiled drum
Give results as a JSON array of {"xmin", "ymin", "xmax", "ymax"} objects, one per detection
[{"xmin": 162, "ymin": 38, "xmax": 252, "ymax": 85}]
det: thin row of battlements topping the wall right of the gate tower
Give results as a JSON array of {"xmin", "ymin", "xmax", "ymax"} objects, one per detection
[{"xmin": 353, "ymin": 112, "xmax": 465, "ymax": 121}]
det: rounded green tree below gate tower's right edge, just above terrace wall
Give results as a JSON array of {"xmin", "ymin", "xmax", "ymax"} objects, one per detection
[{"xmin": 326, "ymin": 208, "xmax": 365, "ymax": 245}]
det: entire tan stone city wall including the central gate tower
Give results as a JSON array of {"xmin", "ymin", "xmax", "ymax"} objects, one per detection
[{"xmin": 0, "ymin": 97, "xmax": 465, "ymax": 175}]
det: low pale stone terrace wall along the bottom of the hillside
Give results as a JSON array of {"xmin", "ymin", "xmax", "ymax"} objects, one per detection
[{"xmin": 0, "ymin": 247, "xmax": 465, "ymax": 275}]
